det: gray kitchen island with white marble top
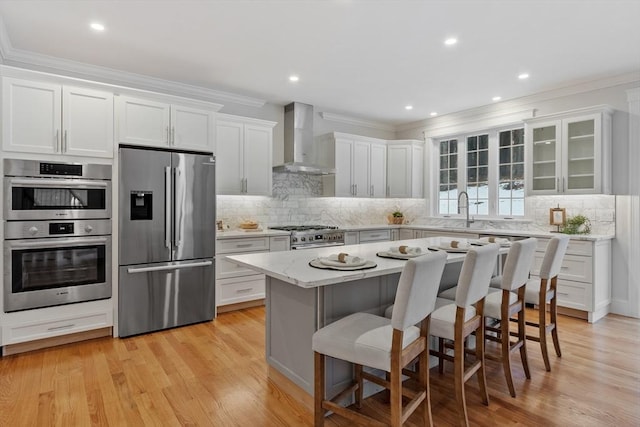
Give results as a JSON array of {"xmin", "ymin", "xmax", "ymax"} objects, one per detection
[{"xmin": 227, "ymin": 237, "xmax": 500, "ymax": 405}]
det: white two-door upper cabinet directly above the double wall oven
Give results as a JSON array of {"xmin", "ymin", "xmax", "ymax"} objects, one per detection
[{"xmin": 2, "ymin": 78, "xmax": 113, "ymax": 158}]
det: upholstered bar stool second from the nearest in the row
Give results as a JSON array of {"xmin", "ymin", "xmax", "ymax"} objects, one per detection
[{"xmin": 430, "ymin": 243, "xmax": 499, "ymax": 425}]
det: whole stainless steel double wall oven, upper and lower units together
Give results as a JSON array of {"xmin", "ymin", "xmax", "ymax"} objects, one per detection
[{"xmin": 4, "ymin": 159, "xmax": 111, "ymax": 312}]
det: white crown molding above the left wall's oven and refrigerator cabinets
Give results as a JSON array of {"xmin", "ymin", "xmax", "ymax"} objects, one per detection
[{"xmin": 0, "ymin": 18, "xmax": 267, "ymax": 108}]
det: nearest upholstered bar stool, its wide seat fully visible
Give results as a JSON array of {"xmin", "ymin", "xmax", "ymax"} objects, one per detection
[{"xmin": 312, "ymin": 252, "xmax": 447, "ymax": 427}]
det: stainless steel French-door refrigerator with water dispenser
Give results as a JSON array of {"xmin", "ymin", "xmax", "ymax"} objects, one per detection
[{"xmin": 118, "ymin": 146, "xmax": 216, "ymax": 337}]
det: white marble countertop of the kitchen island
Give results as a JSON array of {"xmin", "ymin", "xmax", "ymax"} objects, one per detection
[{"xmin": 226, "ymin": 237, "xmax": 508, "ymax": 288}]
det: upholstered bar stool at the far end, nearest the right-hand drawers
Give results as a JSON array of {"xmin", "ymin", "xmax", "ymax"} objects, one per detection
[{"xmin": 524, "ymin": 234, "xmax": 569, "ymax": 371}]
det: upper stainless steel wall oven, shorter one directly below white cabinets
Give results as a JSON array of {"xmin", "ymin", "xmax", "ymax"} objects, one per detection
[{"xmin": 4, "ymin": 159, "xmax": 111, "ymax": 221}]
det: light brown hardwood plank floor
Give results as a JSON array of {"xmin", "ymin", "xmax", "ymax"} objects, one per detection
[{"xmin": 0, "ymin": 307, "xmax": 640, "ymax": 427}]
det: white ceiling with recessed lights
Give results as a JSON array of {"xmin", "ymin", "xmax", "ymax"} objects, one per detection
[{"xmin": 0, "ymin": 0, "xmax": 640, "ymax": 124}]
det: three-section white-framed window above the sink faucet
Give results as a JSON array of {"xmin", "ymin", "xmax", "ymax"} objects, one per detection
[{"xmin": 436, "ymin": 128, "xmax": 525, "ymax": 217}]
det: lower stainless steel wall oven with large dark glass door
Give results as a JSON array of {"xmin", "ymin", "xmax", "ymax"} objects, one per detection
[{"xmin": 4, "ymin": 219, "xmax": 111, "ymax": 312}]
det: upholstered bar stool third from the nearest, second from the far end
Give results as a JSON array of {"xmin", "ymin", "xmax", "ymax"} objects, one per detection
[{"xmin": 484, "ymin": 238, "xmax": 538, "ymax": 397}]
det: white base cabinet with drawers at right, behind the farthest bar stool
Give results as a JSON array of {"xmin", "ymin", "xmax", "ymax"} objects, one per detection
[{"xmin": 531, "ymin": 238, "xmax": 611, "ymax": 322}]
